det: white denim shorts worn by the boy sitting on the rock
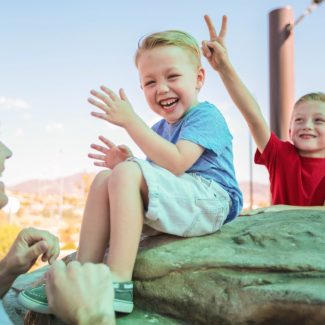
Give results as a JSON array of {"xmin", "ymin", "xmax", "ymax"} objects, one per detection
[{"xmin": 129, "ymin": 158, "xmax": 231, "ymax": 237}]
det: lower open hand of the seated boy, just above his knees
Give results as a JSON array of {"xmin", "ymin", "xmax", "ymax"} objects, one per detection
[{"xmin": 88, "ymin": 136, "xmax": 133, "ymax": 169}]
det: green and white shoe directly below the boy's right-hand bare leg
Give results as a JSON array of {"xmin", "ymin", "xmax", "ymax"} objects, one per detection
[{"xmin": 113, "ymin": 281, "xmax": 133, "ymax": 313}]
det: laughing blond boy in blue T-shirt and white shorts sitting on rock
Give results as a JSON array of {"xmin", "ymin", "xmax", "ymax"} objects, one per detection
[{"xmin": 20, "ymin": 30, "xmax": 242, "ymax": 312}]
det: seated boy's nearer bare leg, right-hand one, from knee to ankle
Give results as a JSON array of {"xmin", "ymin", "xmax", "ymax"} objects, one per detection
[{"xmin": 108, "ymin": 162, "xmax": 148, "ymax": 282}]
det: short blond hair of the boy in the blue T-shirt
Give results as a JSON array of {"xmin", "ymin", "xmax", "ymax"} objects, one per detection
[{"xmin": 134, "ymin": 30, "xmax": 201, "ymax": 67}]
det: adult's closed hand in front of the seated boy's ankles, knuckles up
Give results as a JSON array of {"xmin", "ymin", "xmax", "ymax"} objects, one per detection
[{"xmin": 45, "ymin": 261, "xmax": 115, "ymax": 325}]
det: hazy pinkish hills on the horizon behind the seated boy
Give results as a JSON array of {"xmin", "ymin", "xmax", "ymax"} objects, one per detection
[{"xmin": 9, "ymin": 173, "xmax": 269, "ymax": 204}]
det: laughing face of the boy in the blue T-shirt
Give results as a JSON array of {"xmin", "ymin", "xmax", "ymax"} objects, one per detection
[{"xmin": 137, "ymin": 46, "xmax": 204, "ymax": 123}]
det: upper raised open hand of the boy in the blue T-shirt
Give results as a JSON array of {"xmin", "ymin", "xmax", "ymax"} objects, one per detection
[{"xmin": 88, "ymin": 86, "xmax": 136, "ymax": 127}]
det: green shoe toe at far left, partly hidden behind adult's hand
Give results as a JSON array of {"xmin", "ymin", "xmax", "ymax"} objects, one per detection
[{"xmin": 18, "ymin": 284, "xmax": 50, "ymax": 314}]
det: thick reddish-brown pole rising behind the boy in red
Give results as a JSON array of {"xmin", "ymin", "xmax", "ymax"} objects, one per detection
[{"xmin": 269, "ymin": 7, "xmax": 294, "ymax": 140}]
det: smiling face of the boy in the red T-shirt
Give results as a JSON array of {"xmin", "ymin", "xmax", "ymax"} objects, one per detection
[{"xmin": 290, "ymin": 100, "xmax": 325, "ymax": 158}]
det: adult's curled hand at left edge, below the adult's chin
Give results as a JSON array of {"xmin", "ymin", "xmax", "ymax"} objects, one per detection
[{"xmin": 4, "ymin": 228, "xmax": 60, "ymax": 276}]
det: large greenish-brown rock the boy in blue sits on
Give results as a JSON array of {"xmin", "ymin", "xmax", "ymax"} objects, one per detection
[{"xmin": 4, "ymin": 210, "xmax": 325, "ymax": 325}]
